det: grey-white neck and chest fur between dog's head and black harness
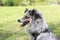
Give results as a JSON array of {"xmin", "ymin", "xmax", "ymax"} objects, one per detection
[{"xmin": 26, "ymin": 19, "xmax": 48, "ymax": 33}]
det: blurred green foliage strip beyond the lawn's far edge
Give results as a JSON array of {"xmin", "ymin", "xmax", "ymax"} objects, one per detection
[{"xmin": 0, "ymin": 0, "xmax": 60, "ymax": 6}]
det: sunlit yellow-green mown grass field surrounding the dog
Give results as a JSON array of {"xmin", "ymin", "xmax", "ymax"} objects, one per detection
[{"xmin": 0, "ymin": 5, "xmax": 60, "ymax": 40}]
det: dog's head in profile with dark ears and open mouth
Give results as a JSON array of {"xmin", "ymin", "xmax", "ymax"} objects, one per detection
[{"xmin": 18, "ymin": 8, "xmax": 42, "ymax": 26}]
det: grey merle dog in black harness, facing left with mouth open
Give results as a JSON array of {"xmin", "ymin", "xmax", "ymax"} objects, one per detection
[{"xmin": 18, "ymin": 8, "xmax": 57, "ymax": 40}]
